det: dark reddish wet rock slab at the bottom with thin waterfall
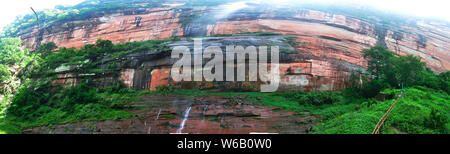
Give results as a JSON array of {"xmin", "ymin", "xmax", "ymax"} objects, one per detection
[{"xmin": 23, "ymin": 95, "xmax": 318, "ymax": 134}]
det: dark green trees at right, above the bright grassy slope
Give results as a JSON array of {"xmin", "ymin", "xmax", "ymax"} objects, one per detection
[{"xmin": 348, "ymin": 47, "xmax": 450, "ymax": 98}]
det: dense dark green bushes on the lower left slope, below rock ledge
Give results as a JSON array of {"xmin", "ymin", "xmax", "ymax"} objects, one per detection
[{"xmin": 9, "ymin": 82, "xmax": 138, "ymax": 127}]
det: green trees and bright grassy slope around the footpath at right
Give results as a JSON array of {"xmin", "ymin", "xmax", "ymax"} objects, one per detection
[{"xmin": 316, "ymin": 47, "xmax": 450, "ymax": 134}]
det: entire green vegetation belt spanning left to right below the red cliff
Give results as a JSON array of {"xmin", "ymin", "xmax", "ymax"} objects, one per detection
[{"xmin": 0, "ymin": 28, "xmax": 450, "ymax": 134}]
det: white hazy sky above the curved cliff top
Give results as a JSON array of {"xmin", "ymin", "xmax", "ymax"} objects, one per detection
[{"xmin": 0, "ymin": 0, "xmax": 450, "ymax": 30}]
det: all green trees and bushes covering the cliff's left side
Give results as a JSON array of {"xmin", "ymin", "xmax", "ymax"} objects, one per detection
[{"xmin": 0, "ymin": 38, "xmax": 176, "ymax": 133}]
